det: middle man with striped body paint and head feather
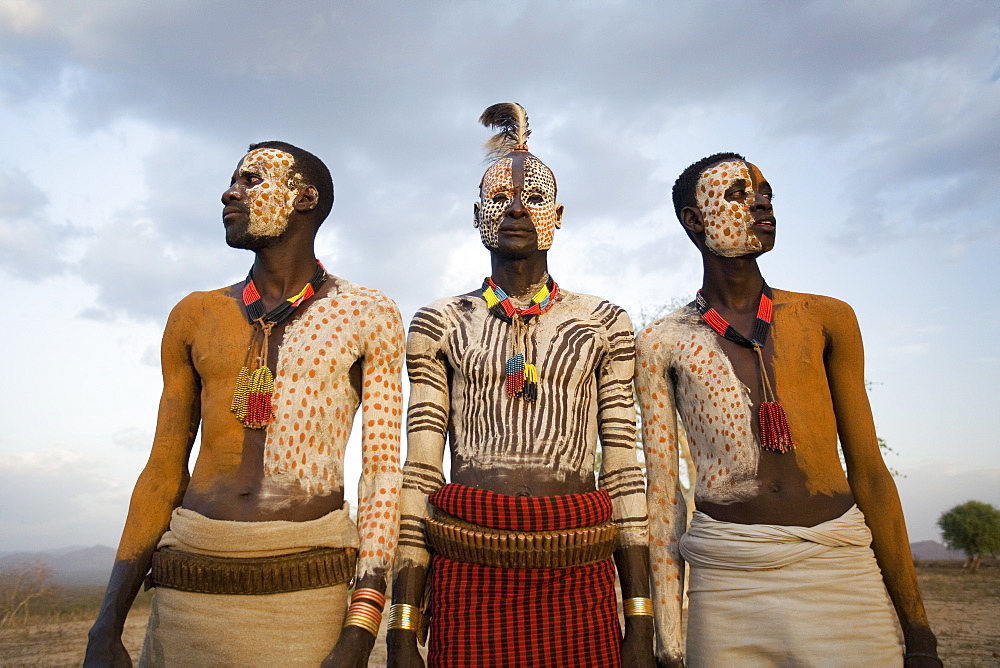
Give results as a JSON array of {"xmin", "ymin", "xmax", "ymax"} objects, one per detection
[{"xmin": 388, "ymin": 105, "xmax": 653, "ymax": 668}]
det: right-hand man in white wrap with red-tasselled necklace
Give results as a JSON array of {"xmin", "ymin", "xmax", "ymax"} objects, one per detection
[{"xmin": 636, "ymin": 153, "xmax": 941, "ymax": 667}]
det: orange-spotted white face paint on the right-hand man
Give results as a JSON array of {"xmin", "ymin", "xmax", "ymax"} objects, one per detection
[{"xmin": 695, "ymin": 161, "xmax": 765, "ymax": 257}]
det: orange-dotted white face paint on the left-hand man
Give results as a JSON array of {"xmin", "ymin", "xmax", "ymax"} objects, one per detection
[{"xmin": 239, "ymin": 148, "xmax": 301, "ymax": 237}]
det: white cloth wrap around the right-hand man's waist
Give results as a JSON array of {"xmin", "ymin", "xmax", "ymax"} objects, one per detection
[{"xmin": 680, "ymin": 506, "xmax": 903, "ymax": 666}]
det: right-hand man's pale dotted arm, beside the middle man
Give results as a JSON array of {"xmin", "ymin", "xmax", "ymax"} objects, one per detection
[{"xmin": 636, "ymin": 328, "xmax": 687, "ymax": 665}]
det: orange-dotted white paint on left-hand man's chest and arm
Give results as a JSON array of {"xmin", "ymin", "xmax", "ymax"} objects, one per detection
[{"xmin": 264, "ymin": 279, "xmax": 404, "ymax": 574}]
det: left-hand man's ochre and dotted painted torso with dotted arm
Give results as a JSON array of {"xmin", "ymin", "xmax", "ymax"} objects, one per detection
[{"xmin": 164, "ymin": 277, "xmax": 403, "ymax": 580}]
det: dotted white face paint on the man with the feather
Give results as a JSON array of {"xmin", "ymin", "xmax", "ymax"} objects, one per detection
[{"xmin": 477, "ymin": 155, "xmax": 559, "ymax": 250}]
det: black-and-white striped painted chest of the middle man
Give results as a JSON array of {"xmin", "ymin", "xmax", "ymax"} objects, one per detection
[{"xmin": 418, "ymin": 292, "xmax": 628, "ymax": 488}]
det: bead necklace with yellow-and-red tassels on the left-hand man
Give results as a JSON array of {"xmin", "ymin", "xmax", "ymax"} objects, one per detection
[{"xmin": 230, "ymin": 260, "xmax": 326, "ymax": 429}]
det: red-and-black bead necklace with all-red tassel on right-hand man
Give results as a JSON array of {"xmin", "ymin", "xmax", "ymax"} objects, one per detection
[{"xmin": 695, "ymin": 283, "xmax": 795, "ymax": 452}]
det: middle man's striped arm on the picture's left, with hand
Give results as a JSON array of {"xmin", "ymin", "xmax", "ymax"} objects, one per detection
[{"xmin": 386, "ymin": 308, "xmax": 449, "ymax": 666}]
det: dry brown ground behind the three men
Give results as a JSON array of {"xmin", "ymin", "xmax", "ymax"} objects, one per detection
[{"xmin": 0, "ymin": 561, "xmax": 1000, "ymax": 667}]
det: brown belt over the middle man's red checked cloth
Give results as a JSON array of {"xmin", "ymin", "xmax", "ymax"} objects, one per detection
[{"xmin": 424, "ymin": 510, "xmax": 618, "ymax": 568}]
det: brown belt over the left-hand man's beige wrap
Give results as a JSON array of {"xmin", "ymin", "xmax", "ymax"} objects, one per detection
[{"xmin": 150, "ymin": 547, "xmax": 357, "ymax": 595}]
